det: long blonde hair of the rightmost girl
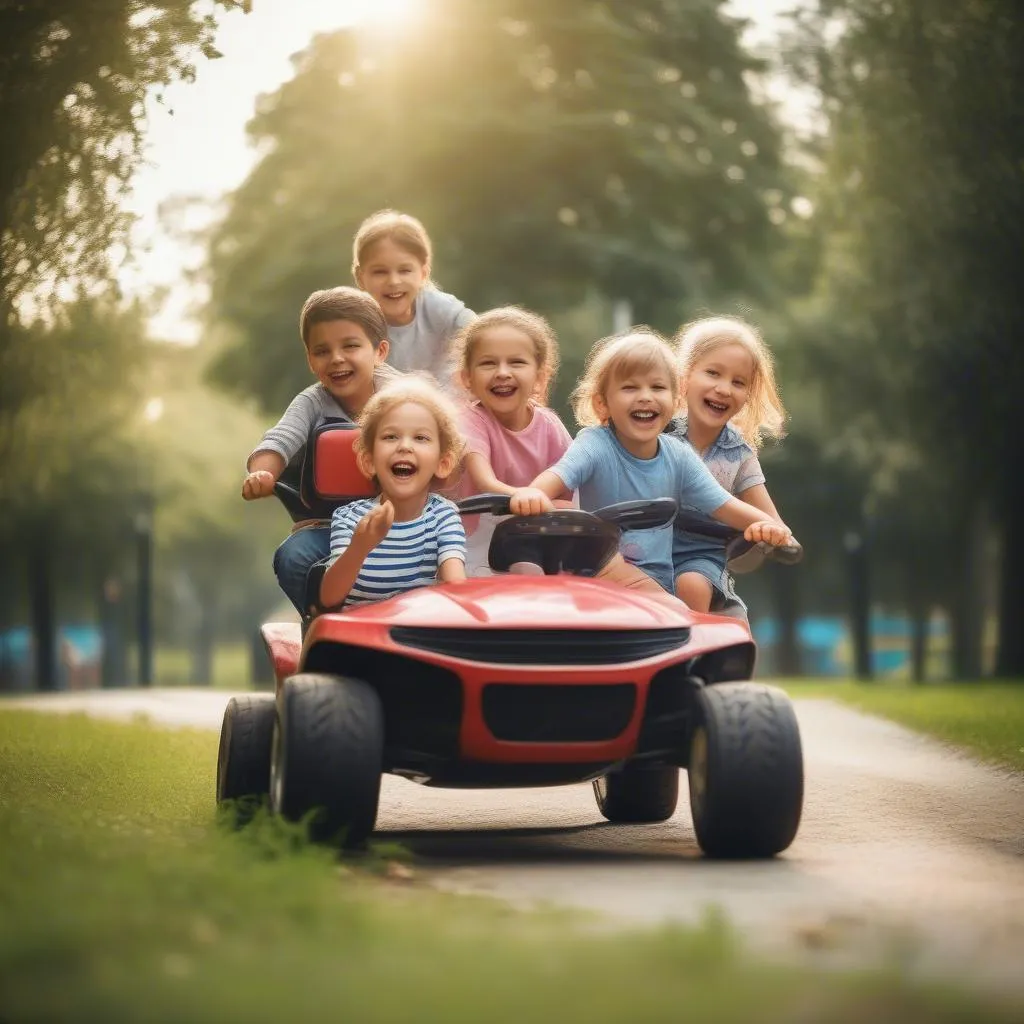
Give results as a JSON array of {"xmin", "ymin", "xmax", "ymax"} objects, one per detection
[{"xmin": 675, "ymin": 316, "xmax": 785, "ymax": 447}]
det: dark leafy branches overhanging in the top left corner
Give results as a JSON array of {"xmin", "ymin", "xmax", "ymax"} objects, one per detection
[{"xmin": 0, "ymin": 0, "xmax": 249, "ymax": 316}]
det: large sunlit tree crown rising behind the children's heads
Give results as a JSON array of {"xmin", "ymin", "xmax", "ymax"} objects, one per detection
[{"xmin": 203, "ymin": 0, "xmax": 786, "ymax": 410}]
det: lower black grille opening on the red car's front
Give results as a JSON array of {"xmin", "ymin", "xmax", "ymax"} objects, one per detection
[{"xmin": 481, "ymin": 683, "xmax": 637, "ymax": 743}]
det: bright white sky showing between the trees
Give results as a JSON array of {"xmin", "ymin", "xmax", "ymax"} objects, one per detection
[{"xmin": 121, "ymin": 0, "xmax": 801, "ymax": 343}]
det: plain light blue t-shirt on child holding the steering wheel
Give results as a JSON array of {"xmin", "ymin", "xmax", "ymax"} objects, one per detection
[{"xmin": 552, "ymin": 427, "xmax": 730, "ymax": 594}]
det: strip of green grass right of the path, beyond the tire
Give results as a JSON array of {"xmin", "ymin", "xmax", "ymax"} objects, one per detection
[{"xmin": 779, "ymin": 680, "xmax": 1024, "ymax": 771}]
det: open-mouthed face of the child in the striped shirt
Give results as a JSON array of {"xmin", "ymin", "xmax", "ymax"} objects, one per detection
[{"xmin": 364, "ymin": 401, "xmax": 453, "ymax": 502}]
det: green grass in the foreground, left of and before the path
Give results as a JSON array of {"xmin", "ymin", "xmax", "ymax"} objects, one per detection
[{"xmin": 0, "ymin": 711, "xmax": 1022, "ymax": 1024}]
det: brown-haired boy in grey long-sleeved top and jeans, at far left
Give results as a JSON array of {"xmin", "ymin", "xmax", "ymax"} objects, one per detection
[{"xmin": 242, "ymin": 288, "xmax": 400, "ymax": 614}]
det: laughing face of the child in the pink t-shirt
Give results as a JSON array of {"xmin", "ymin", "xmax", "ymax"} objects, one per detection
[{"xmin": 463, "ymin": 325, "xmax": 543, "ymax": 429}]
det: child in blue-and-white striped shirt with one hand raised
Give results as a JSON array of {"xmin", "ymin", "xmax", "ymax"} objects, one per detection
[{"xmin": 321, "ymin": 379, "xmax": 466, "ymax": 608}]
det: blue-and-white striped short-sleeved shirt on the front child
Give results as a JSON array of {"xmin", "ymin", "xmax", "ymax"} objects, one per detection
[{"xmin": 331, "ymin": 495, "xmax": 466, "ymax": 606}]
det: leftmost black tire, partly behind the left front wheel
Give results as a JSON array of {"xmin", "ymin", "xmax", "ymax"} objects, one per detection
[{"xmin": 217, "ymin": 693, "xmax": 276, "ymax": 819}]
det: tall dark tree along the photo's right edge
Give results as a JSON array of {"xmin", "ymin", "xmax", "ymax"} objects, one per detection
[{"xmin": 778, "ymin": 0, "xmax": 1024, "ymax": 675}]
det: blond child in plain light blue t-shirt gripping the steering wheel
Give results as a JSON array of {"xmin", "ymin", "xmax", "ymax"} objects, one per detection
[{"xmin": 512, "ymin": 331, "xmax": 790, "ymax": 594}]
